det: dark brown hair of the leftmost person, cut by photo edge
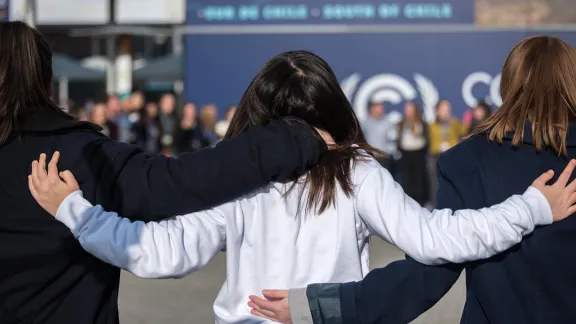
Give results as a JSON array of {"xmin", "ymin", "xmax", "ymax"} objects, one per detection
[{"xmin": 0, "ymin": 21, "xmax": 64, "ymax": 143}]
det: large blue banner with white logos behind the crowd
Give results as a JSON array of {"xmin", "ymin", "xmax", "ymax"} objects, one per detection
[{"xmin": 185, "ymin": 32, "xmax": 576, "ymax": 120}]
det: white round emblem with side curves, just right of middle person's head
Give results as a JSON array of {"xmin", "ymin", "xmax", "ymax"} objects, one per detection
[{"xmin": 340, "ymin": 73, "xmax": 439, "ymax": 122}]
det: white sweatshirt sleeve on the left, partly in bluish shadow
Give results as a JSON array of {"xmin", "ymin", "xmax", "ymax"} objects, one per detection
[{"xmin": 56, "ymin": 191, "xmax": 226, "ymax": 278}]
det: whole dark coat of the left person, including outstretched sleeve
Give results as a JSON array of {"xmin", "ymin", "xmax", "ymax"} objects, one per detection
[{"xmin": 0, "ymin": 108, "xmax": 326, "ymax": 324}]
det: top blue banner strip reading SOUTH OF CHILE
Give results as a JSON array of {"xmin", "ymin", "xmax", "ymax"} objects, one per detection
[{"xmin": 187, "ymin": 0, "xmax": 475, "ymax": 25}]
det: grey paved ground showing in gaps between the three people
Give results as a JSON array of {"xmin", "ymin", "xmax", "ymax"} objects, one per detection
[{"xmin": 120, "ymin": 240, "xmax": 464, "ymax": 324}]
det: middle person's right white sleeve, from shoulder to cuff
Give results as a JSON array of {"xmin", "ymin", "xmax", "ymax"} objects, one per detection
[{"xmin": 357, "ymin": 162, "xmax": 553, "ymax": 265}]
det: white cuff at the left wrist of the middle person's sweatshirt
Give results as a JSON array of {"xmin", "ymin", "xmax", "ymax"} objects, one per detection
[{"xmin": 56, "ymin": 190, "xmax": 94, "ymax": 236}]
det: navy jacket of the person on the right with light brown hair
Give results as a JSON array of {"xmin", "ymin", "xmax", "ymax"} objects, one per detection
[{"xmin": 339, "ymin": 125, "xmax": 576, "ymax": 324}]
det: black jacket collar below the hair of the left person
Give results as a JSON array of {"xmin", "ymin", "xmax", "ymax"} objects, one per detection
[{"xmin": 19, "ymin": 107, "xmax": 102, "ymax": 134}]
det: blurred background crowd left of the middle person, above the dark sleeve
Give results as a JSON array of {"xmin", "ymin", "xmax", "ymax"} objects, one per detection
[{"xmin": 71, "ymin": 91, "xmax": 236, "ymax": 156}]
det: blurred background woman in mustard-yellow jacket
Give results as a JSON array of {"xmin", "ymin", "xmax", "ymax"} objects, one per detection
[{"xmin": 428, "ymin": 100, "xmax": 468, "ymax": 203}]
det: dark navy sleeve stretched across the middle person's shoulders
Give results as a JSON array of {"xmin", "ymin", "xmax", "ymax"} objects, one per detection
[{"xmin": 72, "ymin": 121, "xmax": 327, "ymax": 221}]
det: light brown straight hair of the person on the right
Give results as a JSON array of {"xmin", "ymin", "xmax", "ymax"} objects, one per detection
[{"xmin": 470, "ymin": 36, "xmax": 576, "ymax": 155}]
